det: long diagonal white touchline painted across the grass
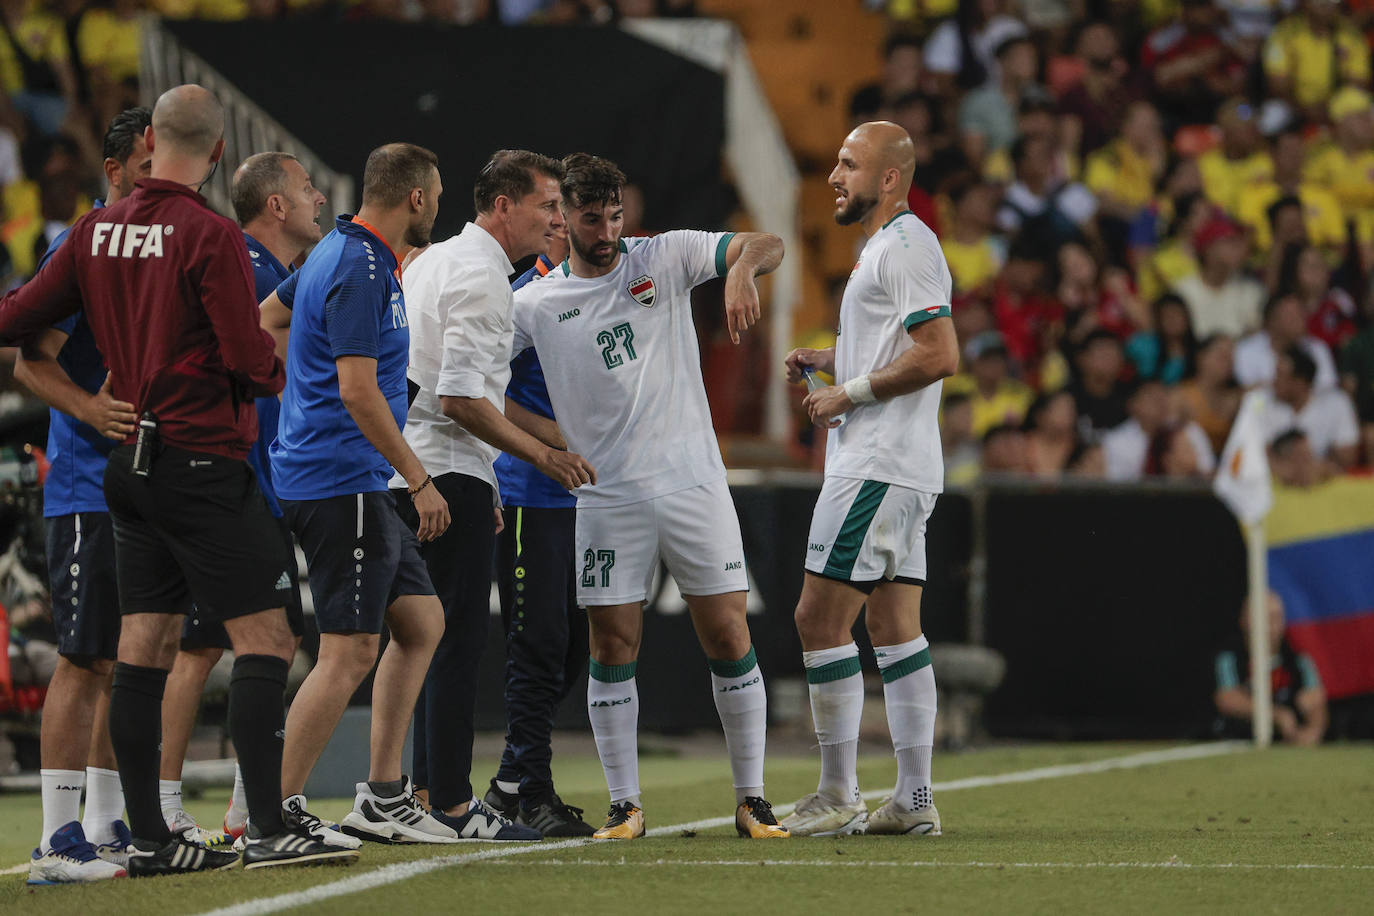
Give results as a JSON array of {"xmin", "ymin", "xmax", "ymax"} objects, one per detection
[{"xmin": 188, "ymin": 742, "xmax": 1250, "ymax": 916}]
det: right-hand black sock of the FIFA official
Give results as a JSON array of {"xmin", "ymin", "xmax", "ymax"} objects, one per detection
[{"xmin": 229, "ymin": 655, "xmax": 290, "ymax": 836}]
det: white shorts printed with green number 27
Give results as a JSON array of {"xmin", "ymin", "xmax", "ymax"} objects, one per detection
[{"xmin": 576, "ymin": 479, "xmax": 749, "ymax": 607}]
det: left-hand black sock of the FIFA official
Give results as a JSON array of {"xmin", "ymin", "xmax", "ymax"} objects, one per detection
[{"xmin": 110, "ymin": 662, "xmax": 172, "ymax": 845}]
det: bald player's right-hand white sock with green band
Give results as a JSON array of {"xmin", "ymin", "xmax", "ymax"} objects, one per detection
[{"xmin": 874, "ymin": 636, "xmax": 936, "ymax": 810}]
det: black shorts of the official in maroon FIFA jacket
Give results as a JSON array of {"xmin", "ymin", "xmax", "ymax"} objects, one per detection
[{"xmin": 104, "ymin": 445, "xmax": 295, "ymax": 621}]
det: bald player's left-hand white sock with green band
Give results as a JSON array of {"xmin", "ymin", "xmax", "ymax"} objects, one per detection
[{"xmin": 801, "ymin": 643, "xmax": 863, "ymax": 805}]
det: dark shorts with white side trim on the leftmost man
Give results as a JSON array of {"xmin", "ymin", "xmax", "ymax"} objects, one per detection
[{"xmin": 45, "ymin": 512, "xmax": 120, "ymax": 665}]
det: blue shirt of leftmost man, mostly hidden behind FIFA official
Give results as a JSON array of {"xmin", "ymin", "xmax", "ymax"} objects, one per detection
[{"xmin": 38, "ymin": 201, "xmax": 118, "ymax": 518}]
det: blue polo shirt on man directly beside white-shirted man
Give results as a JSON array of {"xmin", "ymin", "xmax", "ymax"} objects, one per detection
[{"xmin": 269, "ymin": 217, "xmax": 411, "ymax": 500}]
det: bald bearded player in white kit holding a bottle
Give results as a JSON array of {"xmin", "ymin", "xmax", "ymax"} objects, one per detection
[{"xmin": 783, "ymin": 121, "xmax": 959, "ymax": 836}]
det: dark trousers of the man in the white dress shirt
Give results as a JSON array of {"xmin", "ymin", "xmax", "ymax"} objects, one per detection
[{"xmin": 393, "ymin": 474, "xmax": 496, "ymax": 810}]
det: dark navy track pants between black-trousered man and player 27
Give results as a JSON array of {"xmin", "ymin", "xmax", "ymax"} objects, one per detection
[{"xmin": 496, "ymin": 507, "xmax": 587, "ymax": 798}]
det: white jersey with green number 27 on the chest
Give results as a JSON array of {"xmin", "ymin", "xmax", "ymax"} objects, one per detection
[{"xmin": 514, "ymin": 229, "xmax": 734, "ymax": 507}]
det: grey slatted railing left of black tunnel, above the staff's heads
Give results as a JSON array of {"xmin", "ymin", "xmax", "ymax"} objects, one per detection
[{"xmin": 139, "ymin": 16, "xmax": 356, "ymax": 219}]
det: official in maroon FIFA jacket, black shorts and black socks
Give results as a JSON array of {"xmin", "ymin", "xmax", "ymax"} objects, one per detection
[{"xmin": 0, "ymin": 85, "xmax": 357, "ymax": 876}]
